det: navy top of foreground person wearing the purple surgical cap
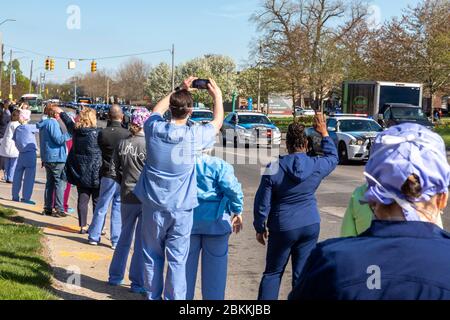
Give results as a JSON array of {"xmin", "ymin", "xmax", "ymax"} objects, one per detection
[{"xmin": 290, "ymin": 221, "xmax": 450, "ymax": 300}]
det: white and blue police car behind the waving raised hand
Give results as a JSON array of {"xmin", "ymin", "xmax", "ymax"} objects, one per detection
[{"xmin": 306, "ymin": 114, "xmax": 383, "ymax": 164}]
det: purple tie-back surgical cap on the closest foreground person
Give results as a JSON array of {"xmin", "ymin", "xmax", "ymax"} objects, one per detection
[{"xmin": 364, "ymin": 123, "xmax": 450, "ymax": 211}]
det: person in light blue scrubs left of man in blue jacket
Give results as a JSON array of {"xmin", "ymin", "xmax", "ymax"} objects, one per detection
[{"xmin": 12, "ymin": 110, "xmax": 39, "ymax": 205}]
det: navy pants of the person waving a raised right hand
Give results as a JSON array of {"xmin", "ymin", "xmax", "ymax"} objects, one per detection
[{"xmin": 258, "ymin": 224, "xmax": 320, "ymax": 301}]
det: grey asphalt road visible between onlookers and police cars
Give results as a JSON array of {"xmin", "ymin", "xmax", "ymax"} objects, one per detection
[{"xmin": 29, "ymin": 115, "xmax": 450, "ymax": 300}]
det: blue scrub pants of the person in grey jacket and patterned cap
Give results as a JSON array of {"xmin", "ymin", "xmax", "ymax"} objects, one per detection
[{"xmin": 109, "ymin": 203, "xmax": 144, "ymax": 293}]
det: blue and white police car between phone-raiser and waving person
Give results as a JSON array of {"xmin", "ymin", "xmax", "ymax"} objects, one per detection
[{"xmin": 222, "ymin": 111, "xmax": 281, "ymax": 148}]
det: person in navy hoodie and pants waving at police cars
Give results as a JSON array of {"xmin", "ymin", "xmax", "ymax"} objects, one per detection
[{"xmin": 254, "ymin": 113, "xmax": 339, "ymax": 300}]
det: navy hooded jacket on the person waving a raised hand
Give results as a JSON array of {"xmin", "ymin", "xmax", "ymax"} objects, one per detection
[{"xmin": 254, "ymin": 137, "xmax": 339, "ymax": 233}]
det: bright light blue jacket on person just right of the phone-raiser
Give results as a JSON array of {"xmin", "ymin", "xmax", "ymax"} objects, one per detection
[{"xmin": 191, "ymin": 154, "xmax": 244, "ymax": 235}]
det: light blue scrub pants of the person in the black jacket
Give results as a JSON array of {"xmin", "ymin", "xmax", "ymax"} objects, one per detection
[{"xmin": 89, "ymin": 178, "xmax": 122, "ymax": 245}]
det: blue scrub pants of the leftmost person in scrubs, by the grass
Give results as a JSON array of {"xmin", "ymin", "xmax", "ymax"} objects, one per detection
[{"xmin": 12, "ymin": 151, "xmax": 37, "ymax": 201}]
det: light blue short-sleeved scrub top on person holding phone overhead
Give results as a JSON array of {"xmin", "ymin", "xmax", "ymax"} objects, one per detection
[{"xmin": 134, "ymin": 113, "xmax": 216, "ymax": 211}]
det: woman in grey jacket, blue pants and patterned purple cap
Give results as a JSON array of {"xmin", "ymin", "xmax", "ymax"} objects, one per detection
[{"xmin": 109, "ymin": 108, "xmax": 150, "ymax": 293}]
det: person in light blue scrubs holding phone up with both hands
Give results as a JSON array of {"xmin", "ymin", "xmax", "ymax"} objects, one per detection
[{"xmin": 134, "ymin": 77, "xmax": 224, "ymax": 300}]
